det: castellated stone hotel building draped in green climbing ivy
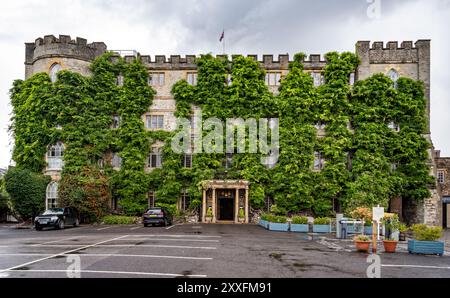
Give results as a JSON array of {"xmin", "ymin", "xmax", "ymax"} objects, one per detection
[{"xmin": 11, "ymin": 36, "xmax": 440, "ymax": 224}]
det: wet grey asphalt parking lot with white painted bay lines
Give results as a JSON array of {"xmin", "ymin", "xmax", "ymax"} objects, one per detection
[{"xmin": 0, "ymin": 224, "xmax": 450, "ymax": 278}]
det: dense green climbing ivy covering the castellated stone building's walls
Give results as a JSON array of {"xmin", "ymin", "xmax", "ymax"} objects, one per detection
[{"xmin": 7, "ymin": 52, "xmax": 432, "ymax": 217}]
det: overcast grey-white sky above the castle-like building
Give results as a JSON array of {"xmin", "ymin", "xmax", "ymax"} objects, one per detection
[{"xmin": 0, "ymin": 0, "xmax": 450, "ymax": 167}]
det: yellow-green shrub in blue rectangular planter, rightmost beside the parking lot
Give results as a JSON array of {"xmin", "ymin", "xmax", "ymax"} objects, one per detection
[{"xmin": 408, "ymin": 224, "xmax": 444, "ymax": 256}]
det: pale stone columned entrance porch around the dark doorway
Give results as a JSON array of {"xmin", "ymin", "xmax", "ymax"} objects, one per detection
[{"xmin": 202, "ymin": 180, "xmax": 249, "ymax": 223}]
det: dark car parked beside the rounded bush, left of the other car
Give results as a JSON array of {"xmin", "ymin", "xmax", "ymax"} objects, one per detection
[{"xmin": 34, "ymin": 207, "xmax": 80, "ymax": 231}]
